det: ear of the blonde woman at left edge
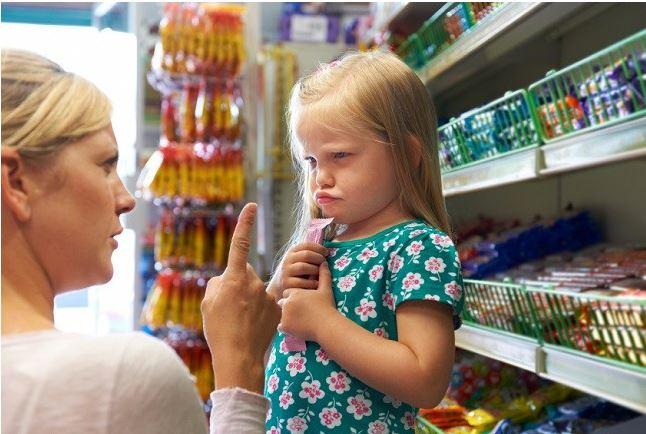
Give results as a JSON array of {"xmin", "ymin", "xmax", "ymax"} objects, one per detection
[{"xmin": 1, "ymin": 147, "xmax": 31, "ymax": 222}]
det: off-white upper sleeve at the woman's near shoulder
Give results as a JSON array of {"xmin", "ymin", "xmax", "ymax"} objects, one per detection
[{"xmin": 106, "ymin": 333, "xmax": 208, "ymax": 434}]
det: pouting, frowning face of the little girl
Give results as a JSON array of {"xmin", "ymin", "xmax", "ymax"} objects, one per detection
[{"xmin": 298, "ymin": 124, "xmax": 404, "ymax": 234}]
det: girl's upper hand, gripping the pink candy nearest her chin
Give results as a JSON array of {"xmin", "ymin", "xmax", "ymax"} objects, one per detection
[{"xmin": 268, "ymin": 243, "xmax": 328, "ymax": 300}]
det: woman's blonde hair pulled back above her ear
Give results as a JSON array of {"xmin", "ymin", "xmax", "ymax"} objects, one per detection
[{"xmin": 1, "ymin": 49, "xmax": 112, "ymax": 159}]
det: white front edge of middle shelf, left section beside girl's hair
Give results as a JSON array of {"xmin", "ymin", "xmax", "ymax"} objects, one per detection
[{"xmin": 442, "ymin": 147, "xmax": 541, "ymax": 196}]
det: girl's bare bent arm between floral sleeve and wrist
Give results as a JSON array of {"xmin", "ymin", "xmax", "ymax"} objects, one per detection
[{"xmin": 315, "ymin": 301, "xmax": 455, "ymax": 408}]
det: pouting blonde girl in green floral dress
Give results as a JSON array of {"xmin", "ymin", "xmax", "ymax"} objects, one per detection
[{"xmin": 265, "ymin": 52, "xmax": 463, "ymax": 433}]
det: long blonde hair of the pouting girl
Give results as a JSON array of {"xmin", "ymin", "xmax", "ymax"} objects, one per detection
[{"xmin": 285, "ymin": 51, "xmax": 450, "ymax": 264}]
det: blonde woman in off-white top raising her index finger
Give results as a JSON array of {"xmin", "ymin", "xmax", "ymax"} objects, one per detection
[{"xmin": 1, "ymin": 50, "xmax": 280, "ymax": 433}]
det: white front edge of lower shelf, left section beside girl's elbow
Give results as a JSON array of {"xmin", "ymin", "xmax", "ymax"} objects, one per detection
[{"xmin": 455, "ymin": 324, "xmax": 540, "ymax": 372}]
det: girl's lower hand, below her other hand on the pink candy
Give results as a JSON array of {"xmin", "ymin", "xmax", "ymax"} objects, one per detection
[{"xmin": 278, "ymin": 261, "xmax": 339, "ymax": 342}]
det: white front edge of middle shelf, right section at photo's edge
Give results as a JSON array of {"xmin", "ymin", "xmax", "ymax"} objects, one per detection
[{"xmin": 540, "ymin": 117, "xmax": 646, "ymax": 175}]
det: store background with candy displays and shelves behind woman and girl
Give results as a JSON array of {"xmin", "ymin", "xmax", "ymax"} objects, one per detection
[{"xmin": 0, "ymin": 2, "xmax": 646, "ymax": 434}]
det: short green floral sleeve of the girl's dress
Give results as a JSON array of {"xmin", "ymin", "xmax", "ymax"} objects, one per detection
[{"xmin": 388, "ymin": 229, "xmax": 464, "ymax": 329}]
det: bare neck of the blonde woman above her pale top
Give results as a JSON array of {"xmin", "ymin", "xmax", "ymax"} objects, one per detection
[{"xmin": 2, "ymin": 227, "xmax": 54, "ymax": 335}]
